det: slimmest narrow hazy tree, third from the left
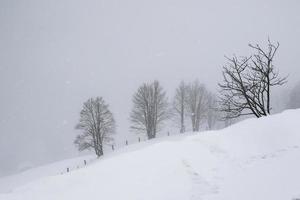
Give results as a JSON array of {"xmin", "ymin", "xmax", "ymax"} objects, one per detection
[{"xmin": 173, "ymin": 81, "xmax": 188, "ymax": 133}]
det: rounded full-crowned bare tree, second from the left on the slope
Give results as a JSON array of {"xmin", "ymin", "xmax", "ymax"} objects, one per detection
[{"xmin": 130, "ymin": 81, "xmax": 169, "ymax": 139}]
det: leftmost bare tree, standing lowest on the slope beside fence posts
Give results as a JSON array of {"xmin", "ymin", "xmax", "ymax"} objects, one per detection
[{"xmin": 74, "ymin": 97, "xmax": 115, "ymax": 157}]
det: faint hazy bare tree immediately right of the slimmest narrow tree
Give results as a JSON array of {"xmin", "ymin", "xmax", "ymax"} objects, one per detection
[{"xmin": 186, "ymin": 80, "xmax": 208, "ymax": 132}]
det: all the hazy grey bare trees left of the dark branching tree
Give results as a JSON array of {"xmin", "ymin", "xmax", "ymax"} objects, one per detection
[{"xmin": 74, "ymin": 80, "xmax": 216, "ymax": 156}]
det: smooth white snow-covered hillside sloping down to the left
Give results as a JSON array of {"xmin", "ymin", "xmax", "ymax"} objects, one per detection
[{"xmin": 0, "ymin": 110, "xmax": 300, "ymax": 200}]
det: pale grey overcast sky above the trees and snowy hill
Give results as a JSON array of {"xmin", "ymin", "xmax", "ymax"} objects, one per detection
[{"xmin": 0, "ymin": 0, "xmax": 300, "ymax": 175}]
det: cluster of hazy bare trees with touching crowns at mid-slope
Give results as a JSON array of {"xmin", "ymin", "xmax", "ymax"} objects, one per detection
[{"xmin": 130, "ymin": 80, "xmax": 218, "ymax": 139}]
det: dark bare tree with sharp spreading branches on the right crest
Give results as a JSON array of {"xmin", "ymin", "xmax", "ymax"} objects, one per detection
[{"xmin": 219, "ymin": 40, "xmax": 287, "ymax": 118}]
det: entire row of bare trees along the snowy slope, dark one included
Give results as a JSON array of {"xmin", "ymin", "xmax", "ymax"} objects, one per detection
[{"xmin": 75, "ymin": 40, "xmax": 287, "ymax": 156}]
